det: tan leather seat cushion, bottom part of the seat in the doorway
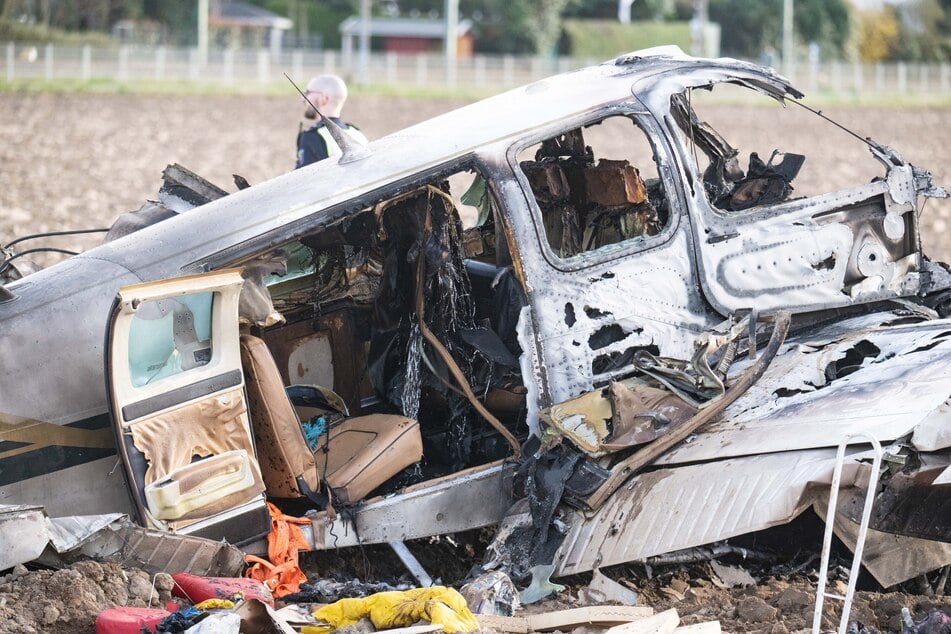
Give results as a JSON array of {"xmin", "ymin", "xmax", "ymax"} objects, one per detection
[{"xmin": 315, "ymin": 414, "xmax": 423, "ymax": 503}]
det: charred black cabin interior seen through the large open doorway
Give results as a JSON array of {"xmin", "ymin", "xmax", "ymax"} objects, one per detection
[{"xmin": 242, "ymin": 171, "xmax": 527, "ymax": 501}]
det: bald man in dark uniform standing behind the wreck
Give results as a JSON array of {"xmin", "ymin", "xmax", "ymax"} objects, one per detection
[{"xmin": 294, "ymin": 75, "xmax": 367, "ymax": 169}]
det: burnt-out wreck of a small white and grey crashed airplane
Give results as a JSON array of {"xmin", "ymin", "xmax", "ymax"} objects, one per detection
[{"xmin": 0, "ymin": 47, "xmax": 951, "ymax": 586}]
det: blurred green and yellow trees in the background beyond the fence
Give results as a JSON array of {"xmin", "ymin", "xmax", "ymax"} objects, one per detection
[{"xmin": 0, "ymin": 0, "xmax": 951, "ymax": 62}]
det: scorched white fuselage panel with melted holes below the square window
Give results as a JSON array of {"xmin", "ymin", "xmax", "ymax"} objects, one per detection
[{"xmin": 522, "ymin": 231, "xmax": 720, "ymax": 407}]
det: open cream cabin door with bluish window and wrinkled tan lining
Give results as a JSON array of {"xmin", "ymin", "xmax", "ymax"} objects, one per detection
[{"xmin": 106, "ymin": 270, "xmax": 270, "ymax": 544}]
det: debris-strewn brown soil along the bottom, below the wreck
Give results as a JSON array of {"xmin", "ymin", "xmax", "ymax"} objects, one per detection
[{"xmin": 0, "ymin": 561, "xmax": 951, "ymax": 634}]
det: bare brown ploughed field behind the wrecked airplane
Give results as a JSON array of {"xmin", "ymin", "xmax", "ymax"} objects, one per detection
[{"xmin": 0, "ymin": 93, "xmax": 951, "ymax": 260}]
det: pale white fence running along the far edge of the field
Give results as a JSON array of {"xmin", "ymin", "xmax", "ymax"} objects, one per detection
[{"xmin": 0, "ymin": 43, "xmax": 951, "ymax": 98}]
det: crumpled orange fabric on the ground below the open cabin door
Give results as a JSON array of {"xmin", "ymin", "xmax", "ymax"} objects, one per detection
[{"xmin": 244, "ymin": 502, "xmax": 310, "ymax": 599}]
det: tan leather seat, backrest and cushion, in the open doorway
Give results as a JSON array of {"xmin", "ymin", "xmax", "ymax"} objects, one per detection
[{"xmin": 241, "ymin": 335, "xmax": 423, "ymax": 502}]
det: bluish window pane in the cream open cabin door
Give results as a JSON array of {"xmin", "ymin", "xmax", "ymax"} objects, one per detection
[{"xmin": 129, "ymin": 293, "xmax": 214, "ymax": 387}]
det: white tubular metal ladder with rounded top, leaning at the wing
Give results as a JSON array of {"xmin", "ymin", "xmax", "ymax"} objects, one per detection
[{"xmin": 812, "ymin": 431, "xmax": 884, "ymax": 634}]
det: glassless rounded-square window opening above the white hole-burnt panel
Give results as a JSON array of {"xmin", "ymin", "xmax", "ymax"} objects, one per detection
[{"xmin": 518, "ymin": 115, "xmax": 670, "ymax": 258}]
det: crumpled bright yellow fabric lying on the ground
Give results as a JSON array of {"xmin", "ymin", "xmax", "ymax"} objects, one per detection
[{"xmin": 301, "ymin": 586, "xmax": 479, "ymax": 634}]
